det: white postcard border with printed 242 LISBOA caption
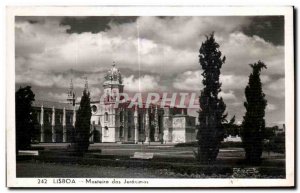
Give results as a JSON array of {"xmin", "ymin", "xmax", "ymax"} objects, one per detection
[{"xmin": 6, "ymin": 6, "xmax": 295, "ymax": 187}]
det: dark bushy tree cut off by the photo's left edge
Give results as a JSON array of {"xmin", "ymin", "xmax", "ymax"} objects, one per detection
[{"xmin": 15, "ymin": 86, "xmax": 35, "ymax": 152}]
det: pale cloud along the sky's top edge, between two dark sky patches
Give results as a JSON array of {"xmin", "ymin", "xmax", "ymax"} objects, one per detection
[{"xmin": 111, "ymin": 17, "xmax": 250, "ymax": 50}]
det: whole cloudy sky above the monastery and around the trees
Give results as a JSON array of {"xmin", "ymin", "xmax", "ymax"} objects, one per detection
[{"xmin": 15, "ymin": 16, "xmax": 285, "ymax": 125}]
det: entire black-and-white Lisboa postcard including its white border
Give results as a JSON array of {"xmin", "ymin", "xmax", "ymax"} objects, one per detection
[{"xmin": 6, "ymin": 7, "xmax": 295, "ymax": 188}]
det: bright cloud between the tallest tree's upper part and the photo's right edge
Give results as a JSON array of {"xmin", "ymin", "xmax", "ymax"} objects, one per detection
[{"xmin": 220, "ymin": 32, "xmax": 284, "ymax": 75}]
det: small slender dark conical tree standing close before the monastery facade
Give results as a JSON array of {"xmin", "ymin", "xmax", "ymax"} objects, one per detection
[{"xmin": 74, "ymin": 89, "xmax": 92, "ymax": 154}]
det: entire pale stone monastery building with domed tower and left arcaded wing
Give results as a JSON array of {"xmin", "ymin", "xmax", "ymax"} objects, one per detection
[{"xmin": 33, "ymin": 65, "xmax": 196, "ymax": 143}]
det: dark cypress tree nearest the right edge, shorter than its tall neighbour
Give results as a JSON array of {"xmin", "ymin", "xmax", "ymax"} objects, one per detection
[{"xmin": 242, "ymin": 61, "xmax": 267, "ymax": 164}]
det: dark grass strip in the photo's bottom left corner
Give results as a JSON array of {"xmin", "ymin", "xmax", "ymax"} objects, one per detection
[{"xmin": 17, "ymin": 162, "xmax": 167, "ymax": 178}]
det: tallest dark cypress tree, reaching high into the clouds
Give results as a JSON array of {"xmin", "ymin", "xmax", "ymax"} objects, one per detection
[{"xmin": 197, "ymin": 34, "xmax": 226, "ymax": 164}]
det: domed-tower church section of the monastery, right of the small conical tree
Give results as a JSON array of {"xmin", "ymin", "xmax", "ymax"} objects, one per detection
[{"xmin": 91, "ymin": 65, "xmax": 196, "ymax": 143}]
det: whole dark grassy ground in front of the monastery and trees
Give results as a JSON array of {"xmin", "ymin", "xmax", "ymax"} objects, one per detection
[{"xmin": 17, "ymin": 143, "xmax": 285, "ymax": 178}]
